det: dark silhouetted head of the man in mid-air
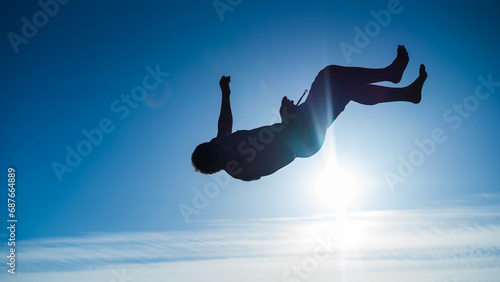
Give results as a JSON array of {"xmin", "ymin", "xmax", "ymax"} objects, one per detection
[{"xmin": 191, "ymin": 142, "xmax": 221, "ymax": 174}]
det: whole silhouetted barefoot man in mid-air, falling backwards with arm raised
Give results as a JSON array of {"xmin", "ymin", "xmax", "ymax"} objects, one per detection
[{"xmin": 191, "ymin": 45, "xmax": 427, "ymax": 181}]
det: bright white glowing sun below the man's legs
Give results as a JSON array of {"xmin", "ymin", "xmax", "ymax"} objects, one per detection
[{"xmin": 315, "ymin": 165, "xmax": 359, "ymax": 215}]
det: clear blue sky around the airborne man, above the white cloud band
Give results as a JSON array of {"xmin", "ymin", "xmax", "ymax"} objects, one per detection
[{"xmin": 0, "ymin": 0, "xmax": 500, "ymax": 281}]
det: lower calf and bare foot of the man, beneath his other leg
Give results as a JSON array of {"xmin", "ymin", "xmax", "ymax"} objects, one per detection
[{"xmin": 342, "ymin": 65, "xmax": 427, "ymax": 105}]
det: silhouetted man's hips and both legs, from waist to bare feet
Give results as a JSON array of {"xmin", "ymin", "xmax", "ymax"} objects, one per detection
[{"xmin": 296, "ymin": 46, "xmax": 427, "ymax": 158}]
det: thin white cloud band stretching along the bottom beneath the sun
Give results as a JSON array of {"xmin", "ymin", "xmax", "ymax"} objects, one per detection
[{"xmin": 0, "ymin": 207, "xmax": 500, "ymax": 281}]
